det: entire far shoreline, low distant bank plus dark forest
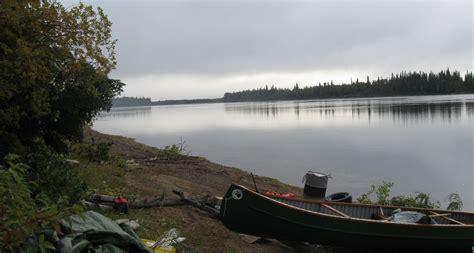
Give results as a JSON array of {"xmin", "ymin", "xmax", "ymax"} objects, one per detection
[{"xmin": 112, "ymin": 68, "xmax": 474, "ymax": 107}]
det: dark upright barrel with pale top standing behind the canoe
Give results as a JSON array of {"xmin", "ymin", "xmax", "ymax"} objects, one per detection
[{"xmin": 303, "ymin": 171, "xmax": 329, "ymax": 199}]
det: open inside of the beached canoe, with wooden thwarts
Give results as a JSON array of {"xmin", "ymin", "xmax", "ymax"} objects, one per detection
[{"xmin": 270, "ymin": 197, "xmax": 474, "ymax": 226}]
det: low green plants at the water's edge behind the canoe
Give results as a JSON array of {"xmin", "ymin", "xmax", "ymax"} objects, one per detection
[{"xmin": 356, "ymin": 181, "xmax": 462, "ymax": 210}]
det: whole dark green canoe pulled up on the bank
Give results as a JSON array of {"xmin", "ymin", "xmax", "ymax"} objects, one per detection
[{"xmin": 220, "ymin": 184, "xmax": 474, "ymax": 251}]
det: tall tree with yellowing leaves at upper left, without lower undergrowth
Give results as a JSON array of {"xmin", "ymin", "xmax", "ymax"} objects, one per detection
[{"xmin": 0, "ymin": 0, "xmax": 123, "ymax": 157}]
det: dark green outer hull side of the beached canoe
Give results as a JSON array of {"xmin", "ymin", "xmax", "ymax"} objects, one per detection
[{"xmin": 221, "ymin": 184, "xmax": 474, "ymax": 249}]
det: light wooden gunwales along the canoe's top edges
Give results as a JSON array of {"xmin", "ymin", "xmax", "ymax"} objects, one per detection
[{"xmin": 231, "ymin": 183, "xmax": 474, "ymax": 229}]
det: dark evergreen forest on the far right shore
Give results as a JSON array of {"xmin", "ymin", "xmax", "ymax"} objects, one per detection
[{"xmin": 223, "ymin": 69, "xmax": 474, "ymax": 102}]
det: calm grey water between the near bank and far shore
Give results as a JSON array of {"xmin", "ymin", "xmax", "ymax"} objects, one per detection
[{"xmin": 94, "ymin": 95, "xmax": 474, "ymax": 211}]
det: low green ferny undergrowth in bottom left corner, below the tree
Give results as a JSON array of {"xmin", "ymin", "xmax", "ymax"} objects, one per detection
[{"xmin": 0, "ymin": 155, "xmax": 81, "ymax": 252}]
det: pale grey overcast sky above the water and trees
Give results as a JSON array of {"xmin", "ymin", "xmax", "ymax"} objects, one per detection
[{"xmin": 73, "ymin": 0, "xmax": 474, "ymax": 100}]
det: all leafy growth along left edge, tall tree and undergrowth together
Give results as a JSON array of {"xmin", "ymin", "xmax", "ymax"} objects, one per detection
[{"xmin": 0, "ymin": 0, "xmax": 124, "ymax": 252}]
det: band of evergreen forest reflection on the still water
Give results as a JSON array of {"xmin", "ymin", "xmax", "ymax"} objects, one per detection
[{"xmin": 224, "ymin": 99, "xmax": 474, "ymax": 122}]
